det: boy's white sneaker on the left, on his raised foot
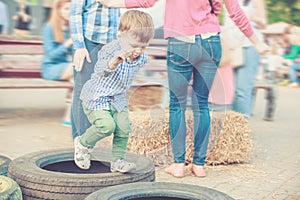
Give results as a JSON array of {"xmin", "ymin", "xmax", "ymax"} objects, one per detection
[{"xmin": 74, "ymin": 136, "xmax": 92, "ymax": 169}]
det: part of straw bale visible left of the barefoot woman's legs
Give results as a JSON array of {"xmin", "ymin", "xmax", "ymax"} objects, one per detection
[{"xmin": 127, "ymin": 107, "xmax": 173, "ymax": 166}]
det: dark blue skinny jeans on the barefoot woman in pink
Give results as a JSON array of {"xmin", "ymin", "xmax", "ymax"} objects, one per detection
[{"xmin": 167, "ymin": 35, "xmax": 222, "ymax": 166}]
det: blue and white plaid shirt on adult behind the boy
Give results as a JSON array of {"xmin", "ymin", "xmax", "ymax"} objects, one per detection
[{"xmin": 70, "ymin": 0, "xmax": 120, "ymax": 49}]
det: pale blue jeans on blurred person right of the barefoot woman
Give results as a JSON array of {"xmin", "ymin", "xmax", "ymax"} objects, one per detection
[{"xmin": 232, "ymin": 46, "xmax": 260, "ymax": 119}]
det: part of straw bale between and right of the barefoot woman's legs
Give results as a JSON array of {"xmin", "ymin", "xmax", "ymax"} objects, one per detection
[{"xmin": 186, "ymin": 111, "xmax": 252, "ymax": 165}]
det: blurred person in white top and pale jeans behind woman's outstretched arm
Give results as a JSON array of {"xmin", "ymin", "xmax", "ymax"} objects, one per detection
[{"xmin": 224, "ymin": 0, "xmax": 266, "ymax": 120}]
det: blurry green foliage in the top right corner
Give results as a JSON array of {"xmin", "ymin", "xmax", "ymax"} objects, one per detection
[{"xmin": 265, "ymin": 0, "xmax": 300, "ymax": 26}]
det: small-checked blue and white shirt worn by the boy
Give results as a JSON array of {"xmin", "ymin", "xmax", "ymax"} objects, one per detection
[{"xmin": 80, "ymin": 40, "xmax": 148, "ymax": 112}]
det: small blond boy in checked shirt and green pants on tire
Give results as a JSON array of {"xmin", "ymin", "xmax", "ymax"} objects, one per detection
[{"xmin": 74, "ymin": 10, "xmax": 154, "ymax": 173}]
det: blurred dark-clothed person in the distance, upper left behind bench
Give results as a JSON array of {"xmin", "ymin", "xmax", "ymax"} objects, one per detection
[{"xmin": 12, "ymin": 0, "xmax": 31, "ymax": 36}]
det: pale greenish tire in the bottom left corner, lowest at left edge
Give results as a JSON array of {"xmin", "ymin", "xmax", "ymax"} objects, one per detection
[{"xmin": 0, "ymin": 176, "xmax": 22, "ymax": 200}]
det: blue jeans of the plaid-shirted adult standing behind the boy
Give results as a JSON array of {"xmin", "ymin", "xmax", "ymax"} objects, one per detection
[{"xmin": 71, "ymin": 39, "xmax": 103, "ymax": 138}]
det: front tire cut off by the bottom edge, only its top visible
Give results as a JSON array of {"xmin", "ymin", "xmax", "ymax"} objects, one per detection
[{"xmin": 85, "ymin": 182, "xmax": 233, "ymax": 200}]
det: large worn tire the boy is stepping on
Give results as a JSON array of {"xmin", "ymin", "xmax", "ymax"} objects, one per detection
[{"xmin": 8, "ymin": 149, "xmax": 155, "ymax": 200}]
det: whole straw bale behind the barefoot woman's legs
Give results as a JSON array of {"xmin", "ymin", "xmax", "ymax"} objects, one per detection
[{"xmin": 128, "ymin": 109, "xmax": 252, "ymax": 166}]
